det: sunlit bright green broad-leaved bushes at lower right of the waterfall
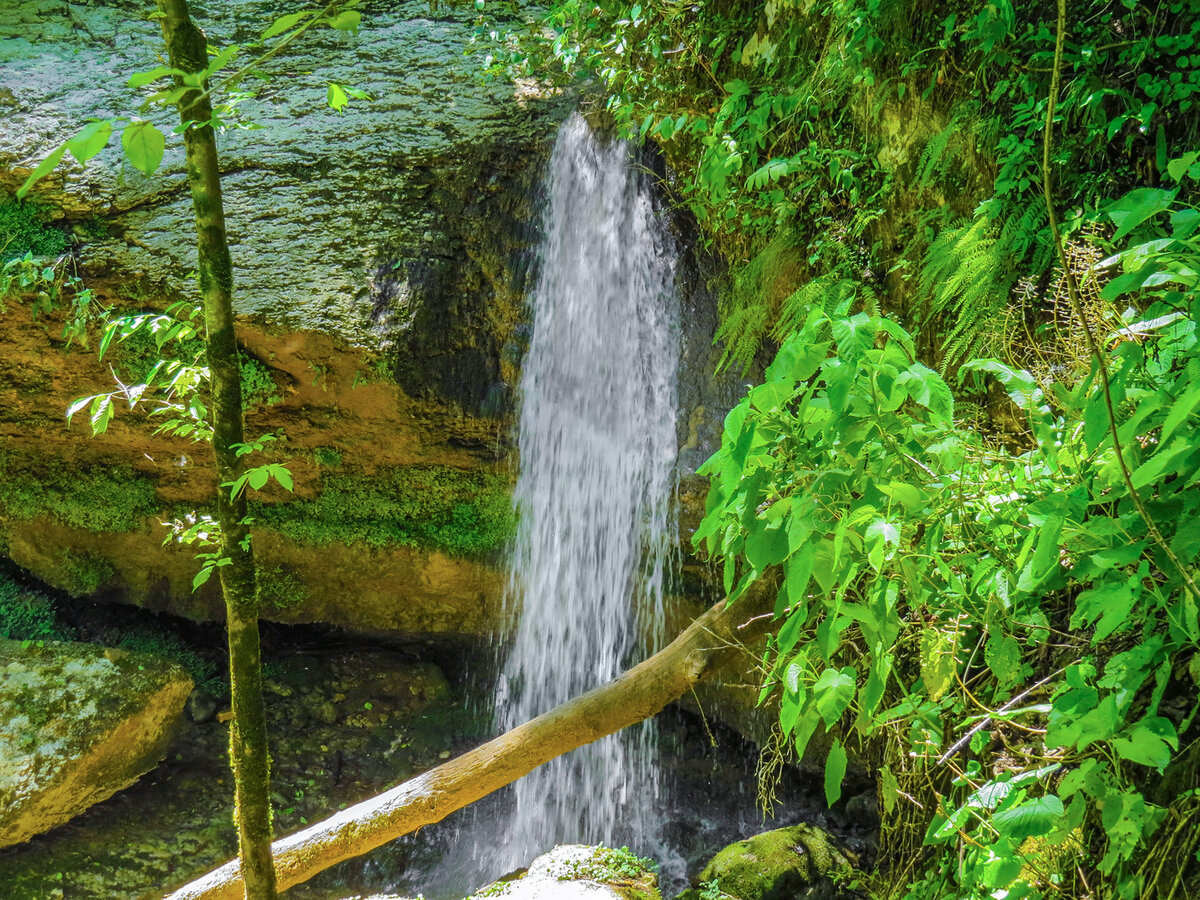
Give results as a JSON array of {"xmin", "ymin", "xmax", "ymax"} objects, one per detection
[{"xmin": 695, "ymin": 164, "xmax": 1200, "ymax": 898}]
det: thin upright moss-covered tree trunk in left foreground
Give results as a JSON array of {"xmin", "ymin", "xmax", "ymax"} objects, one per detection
[{"xmin": 157, "ymin": 0, "xmax": 277, "ymax": 900}]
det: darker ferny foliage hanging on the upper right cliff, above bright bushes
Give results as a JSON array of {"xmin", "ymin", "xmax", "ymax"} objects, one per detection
[{"xmin": 476, "ymin": 0, "xmax": 1200, "ymax": 379}]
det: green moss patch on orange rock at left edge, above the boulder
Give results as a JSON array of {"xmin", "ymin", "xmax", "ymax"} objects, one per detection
[{"xmin": 0, "ymin": 452, "xmax": 158, "ymax": 532}]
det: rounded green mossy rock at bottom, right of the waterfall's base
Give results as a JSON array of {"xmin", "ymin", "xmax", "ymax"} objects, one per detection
[{"xmin": 679, "ymin": 824, "xmax": 850, "ymax": 900}]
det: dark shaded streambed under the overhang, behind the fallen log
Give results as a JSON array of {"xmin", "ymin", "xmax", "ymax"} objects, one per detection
[{"xmin": 0, "ymin": 646, "xmax": 480, "ymax": 900}]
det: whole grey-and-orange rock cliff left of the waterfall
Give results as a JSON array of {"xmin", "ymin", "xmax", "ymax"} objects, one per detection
[{"xmin": 0, "ymin": 0, "xmax": 569, "ymax": 636}]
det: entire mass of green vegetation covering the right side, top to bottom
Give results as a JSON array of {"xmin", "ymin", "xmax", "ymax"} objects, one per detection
[{"xmin": 468, "ymin": 0, "xmax": 1200, "ymax": 898}]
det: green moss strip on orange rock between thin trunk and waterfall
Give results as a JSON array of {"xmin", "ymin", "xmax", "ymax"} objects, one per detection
[{"xmin": 253, "ymin": 466, "xmax": 514, "ymax": 556}]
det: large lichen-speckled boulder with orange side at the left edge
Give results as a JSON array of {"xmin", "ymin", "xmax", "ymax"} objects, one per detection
[{"xmin": 0, "ymin": 641, "xmax": 192, "ymax": 847}]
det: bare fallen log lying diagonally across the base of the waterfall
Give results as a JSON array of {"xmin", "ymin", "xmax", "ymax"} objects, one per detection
[{"xmin": 167, "ymin": 589, "xmax": 772, "ymax": 900}]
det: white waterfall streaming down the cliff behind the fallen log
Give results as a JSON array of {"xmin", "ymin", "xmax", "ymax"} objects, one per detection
[{"xmin": 484, "ymin": 115, "xmax": 679, "ymax": 869}]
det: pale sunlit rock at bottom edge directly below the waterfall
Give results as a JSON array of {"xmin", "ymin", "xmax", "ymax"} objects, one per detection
[{"xmin": 470, "ymin": 844, "xmax": 660, "ymax": 900}]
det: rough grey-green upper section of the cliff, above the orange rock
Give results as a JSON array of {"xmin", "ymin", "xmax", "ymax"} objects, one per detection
[{"xmin": 0, "ymin": 0, "xmax": 563, "ymax": 400}]
